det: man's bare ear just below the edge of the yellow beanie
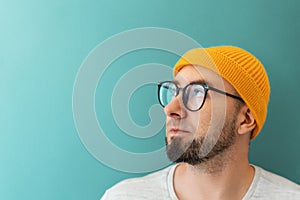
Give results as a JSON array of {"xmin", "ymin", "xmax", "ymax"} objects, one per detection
[{"xmin": 238, "ymin": 105, "xmax": 256, "ymax": 135}]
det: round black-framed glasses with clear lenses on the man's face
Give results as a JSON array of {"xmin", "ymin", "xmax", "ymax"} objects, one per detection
[{"xmin": 158, "ymin": 81, "xmax": 244, "ymax": 112}]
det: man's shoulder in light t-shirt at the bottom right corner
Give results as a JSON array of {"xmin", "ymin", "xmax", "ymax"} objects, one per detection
[{"xmin": 254, "ymin": 166, "xmax": 300, "ymax": 199}]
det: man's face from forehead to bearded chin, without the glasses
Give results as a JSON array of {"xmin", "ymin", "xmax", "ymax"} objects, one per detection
[{"xmin": 164, "ymin": 66, "xmax": 238, "ymax": 165}]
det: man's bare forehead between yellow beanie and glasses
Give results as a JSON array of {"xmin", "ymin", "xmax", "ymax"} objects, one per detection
[{"xmin": 174, "ymin": 65, "xmax": 234, "ymax": 90}]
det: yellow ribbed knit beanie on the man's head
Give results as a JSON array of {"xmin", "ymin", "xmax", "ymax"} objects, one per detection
[{"xmin": 174, "ymin": 46, "xmax": 270, "ymax": 139}]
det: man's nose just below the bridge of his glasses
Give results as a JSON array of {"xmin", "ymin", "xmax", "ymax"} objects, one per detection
[{"xmin": 164, "ymin": 94, "xmax": 186, "ymax": 119}]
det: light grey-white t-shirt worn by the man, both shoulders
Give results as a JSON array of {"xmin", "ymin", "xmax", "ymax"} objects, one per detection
[{"xmin": 101, "ymin": 165, "xmax": 300, "ymax": 200}]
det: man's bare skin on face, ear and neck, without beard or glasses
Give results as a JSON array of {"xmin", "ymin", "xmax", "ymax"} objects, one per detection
[{"xmin": 164, "ymin": 66, "xmax": 256, "ymax": 200}]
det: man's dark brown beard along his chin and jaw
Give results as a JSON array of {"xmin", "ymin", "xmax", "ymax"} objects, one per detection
[{"xmin": 166, "ymin": 114, "xmax": 237, "ymax": 166}]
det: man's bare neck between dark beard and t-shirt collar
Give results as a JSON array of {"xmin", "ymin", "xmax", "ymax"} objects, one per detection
[{"xmin": 174, "ymin": 145, "xmax": 254, "ymax": 200}]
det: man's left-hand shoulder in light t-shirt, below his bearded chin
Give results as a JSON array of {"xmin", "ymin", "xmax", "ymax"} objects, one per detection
[{"xmin": 102, "ymin": 165, "xmax": 174, "ymax": 199}]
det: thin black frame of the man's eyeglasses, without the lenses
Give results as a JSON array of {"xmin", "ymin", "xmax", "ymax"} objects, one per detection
[{"xmin": 157, "ymin": 81, "xmax": 244, "ymax": 112}]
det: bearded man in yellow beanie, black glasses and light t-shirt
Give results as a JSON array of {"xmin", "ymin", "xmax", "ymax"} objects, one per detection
[{"xmin": 102, "ymin": 46, "xmax": 300, "ymax": 200}]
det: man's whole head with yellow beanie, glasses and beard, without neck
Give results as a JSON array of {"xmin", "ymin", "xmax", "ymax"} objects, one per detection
[{"xmin": 160, "ymin": 46, "xmax": 270, "ymax": 167}]
